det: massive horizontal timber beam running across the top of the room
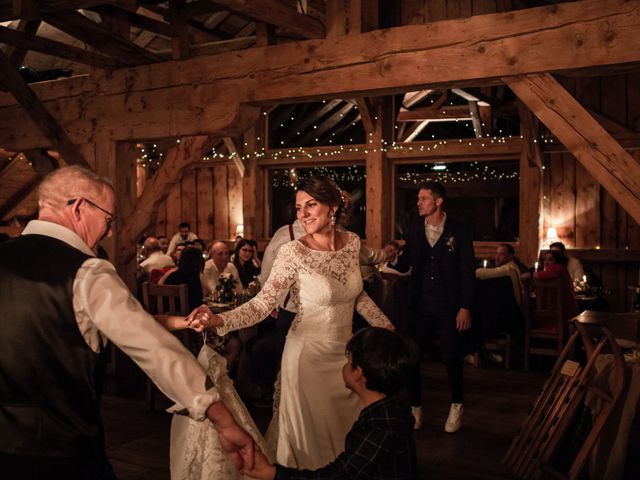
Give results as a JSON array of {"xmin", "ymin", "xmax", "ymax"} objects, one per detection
[{"xmin": 0, "ymin": 0, "xmax": 640, "ymax": 148}]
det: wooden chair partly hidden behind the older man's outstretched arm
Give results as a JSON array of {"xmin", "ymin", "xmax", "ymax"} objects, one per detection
[{"xmin": 142, "ymin": 282, "xmax": 190, "ymax": 411}]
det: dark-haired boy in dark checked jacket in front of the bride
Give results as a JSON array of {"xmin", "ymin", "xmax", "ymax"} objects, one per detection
[{"xmin": 243, "ymin": 327, "xmax": 418, "ymax": 480}]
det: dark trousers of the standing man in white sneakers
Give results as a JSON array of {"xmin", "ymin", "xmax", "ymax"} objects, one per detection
[{"xmin": 407, "ymin": 299, "xmax": 464, "ymax": 407}]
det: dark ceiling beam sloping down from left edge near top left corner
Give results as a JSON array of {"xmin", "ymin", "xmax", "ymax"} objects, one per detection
[{"xmin": 0, "ymin": 26, "xmax": 123, "ymax": 70}]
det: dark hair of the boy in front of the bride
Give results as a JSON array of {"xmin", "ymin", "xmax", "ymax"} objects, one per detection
[{"xmin": 346, "ymin": 327, "xmax": 417, "ymax": 395}]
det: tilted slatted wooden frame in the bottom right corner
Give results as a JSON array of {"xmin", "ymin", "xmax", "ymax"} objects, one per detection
[{"xmin": 503, "ymin": 316, "xmax": 628, "ymax": 480}]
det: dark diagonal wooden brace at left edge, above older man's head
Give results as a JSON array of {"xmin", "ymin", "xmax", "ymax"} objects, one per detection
[{"xmin": 0, "ymin": 50, "xmax": 90, "ymax": 168}]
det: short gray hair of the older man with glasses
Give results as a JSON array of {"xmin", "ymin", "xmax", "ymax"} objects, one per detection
[{"xmin": 38, "ymin": 165, "xmax": 113, "ymax": 209}]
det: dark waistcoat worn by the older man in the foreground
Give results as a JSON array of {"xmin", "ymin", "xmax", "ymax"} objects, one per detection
[{"xmin": 0, "ymin": 235, "xmax": 103, "ymax": 457}]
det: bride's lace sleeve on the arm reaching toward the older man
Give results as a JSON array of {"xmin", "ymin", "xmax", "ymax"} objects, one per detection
[{"xmin": 216, "ymin": 242, "xmax": 298, "ymax": 335}]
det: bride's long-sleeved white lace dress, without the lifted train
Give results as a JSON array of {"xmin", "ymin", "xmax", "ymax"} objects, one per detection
[{"xmin": 217, "ymin": 233, "xmax": 389, "ymax": 469}]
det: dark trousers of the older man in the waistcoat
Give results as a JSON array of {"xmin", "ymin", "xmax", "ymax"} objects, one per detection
[{"xmin": 0, "ymin": 453, "xmax": 116, "ymax": 480}]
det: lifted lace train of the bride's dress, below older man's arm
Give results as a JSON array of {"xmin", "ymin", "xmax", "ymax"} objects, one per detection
[{"xmin": 169, "ymin": 344, "xmax": 266, "ymax": 480}]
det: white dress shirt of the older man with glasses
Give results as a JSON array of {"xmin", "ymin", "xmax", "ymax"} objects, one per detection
[{"xmin": 22, "ymin": 220, "xmax": 220, "ymax": 420}]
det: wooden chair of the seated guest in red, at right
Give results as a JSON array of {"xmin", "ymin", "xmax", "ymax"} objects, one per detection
[{"xmin": 524, "ymin": 279, "xmax": 567, "ymax": 370}]
